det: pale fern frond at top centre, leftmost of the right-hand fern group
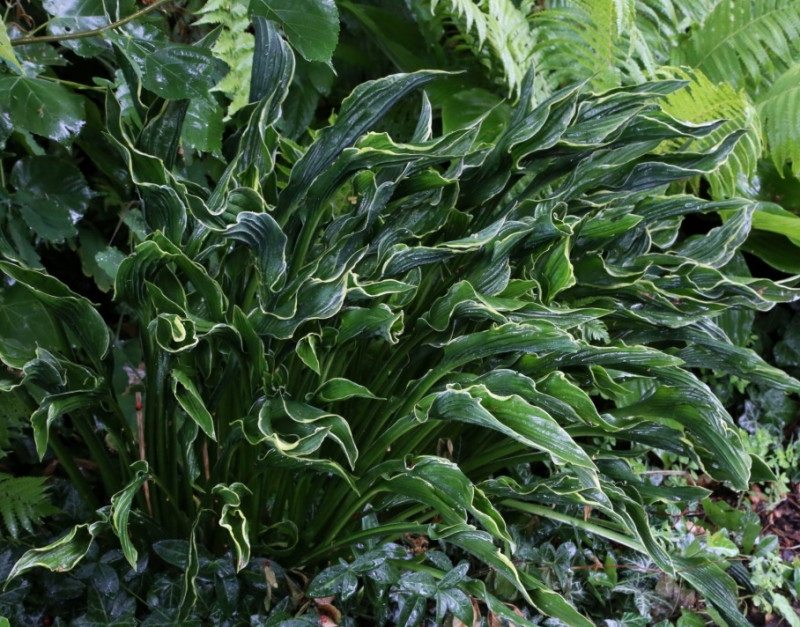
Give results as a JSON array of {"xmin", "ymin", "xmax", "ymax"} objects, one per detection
[{"xmin": 430, "ymin": 0, "xmax": 534, "ymax": 93}]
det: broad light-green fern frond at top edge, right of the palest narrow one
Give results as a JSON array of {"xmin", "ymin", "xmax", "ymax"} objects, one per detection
[{"xmin": 532, "ymin": 0, "xmax": 656, "ymax": 89}]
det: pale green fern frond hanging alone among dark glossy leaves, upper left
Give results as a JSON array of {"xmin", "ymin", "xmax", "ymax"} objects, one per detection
[{"xmin": 197, "ymin": 0, "xmax": 255, "ymax": 116}]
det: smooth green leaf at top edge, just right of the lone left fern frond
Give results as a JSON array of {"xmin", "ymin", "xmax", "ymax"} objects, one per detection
[{"xmin": 250, "ymin": 0, "xmax": 339, "ymax": 63}]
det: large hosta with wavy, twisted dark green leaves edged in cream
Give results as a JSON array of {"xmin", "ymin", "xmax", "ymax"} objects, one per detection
[{"xmin": 0, "ymin": 11, "xmax": 800, "ymax": 625}]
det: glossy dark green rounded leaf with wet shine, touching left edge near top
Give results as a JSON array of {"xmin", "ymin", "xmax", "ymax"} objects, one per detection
[{"xmin": 0, "ymin": 76, "xmax": 84, "ymax": 144}]
